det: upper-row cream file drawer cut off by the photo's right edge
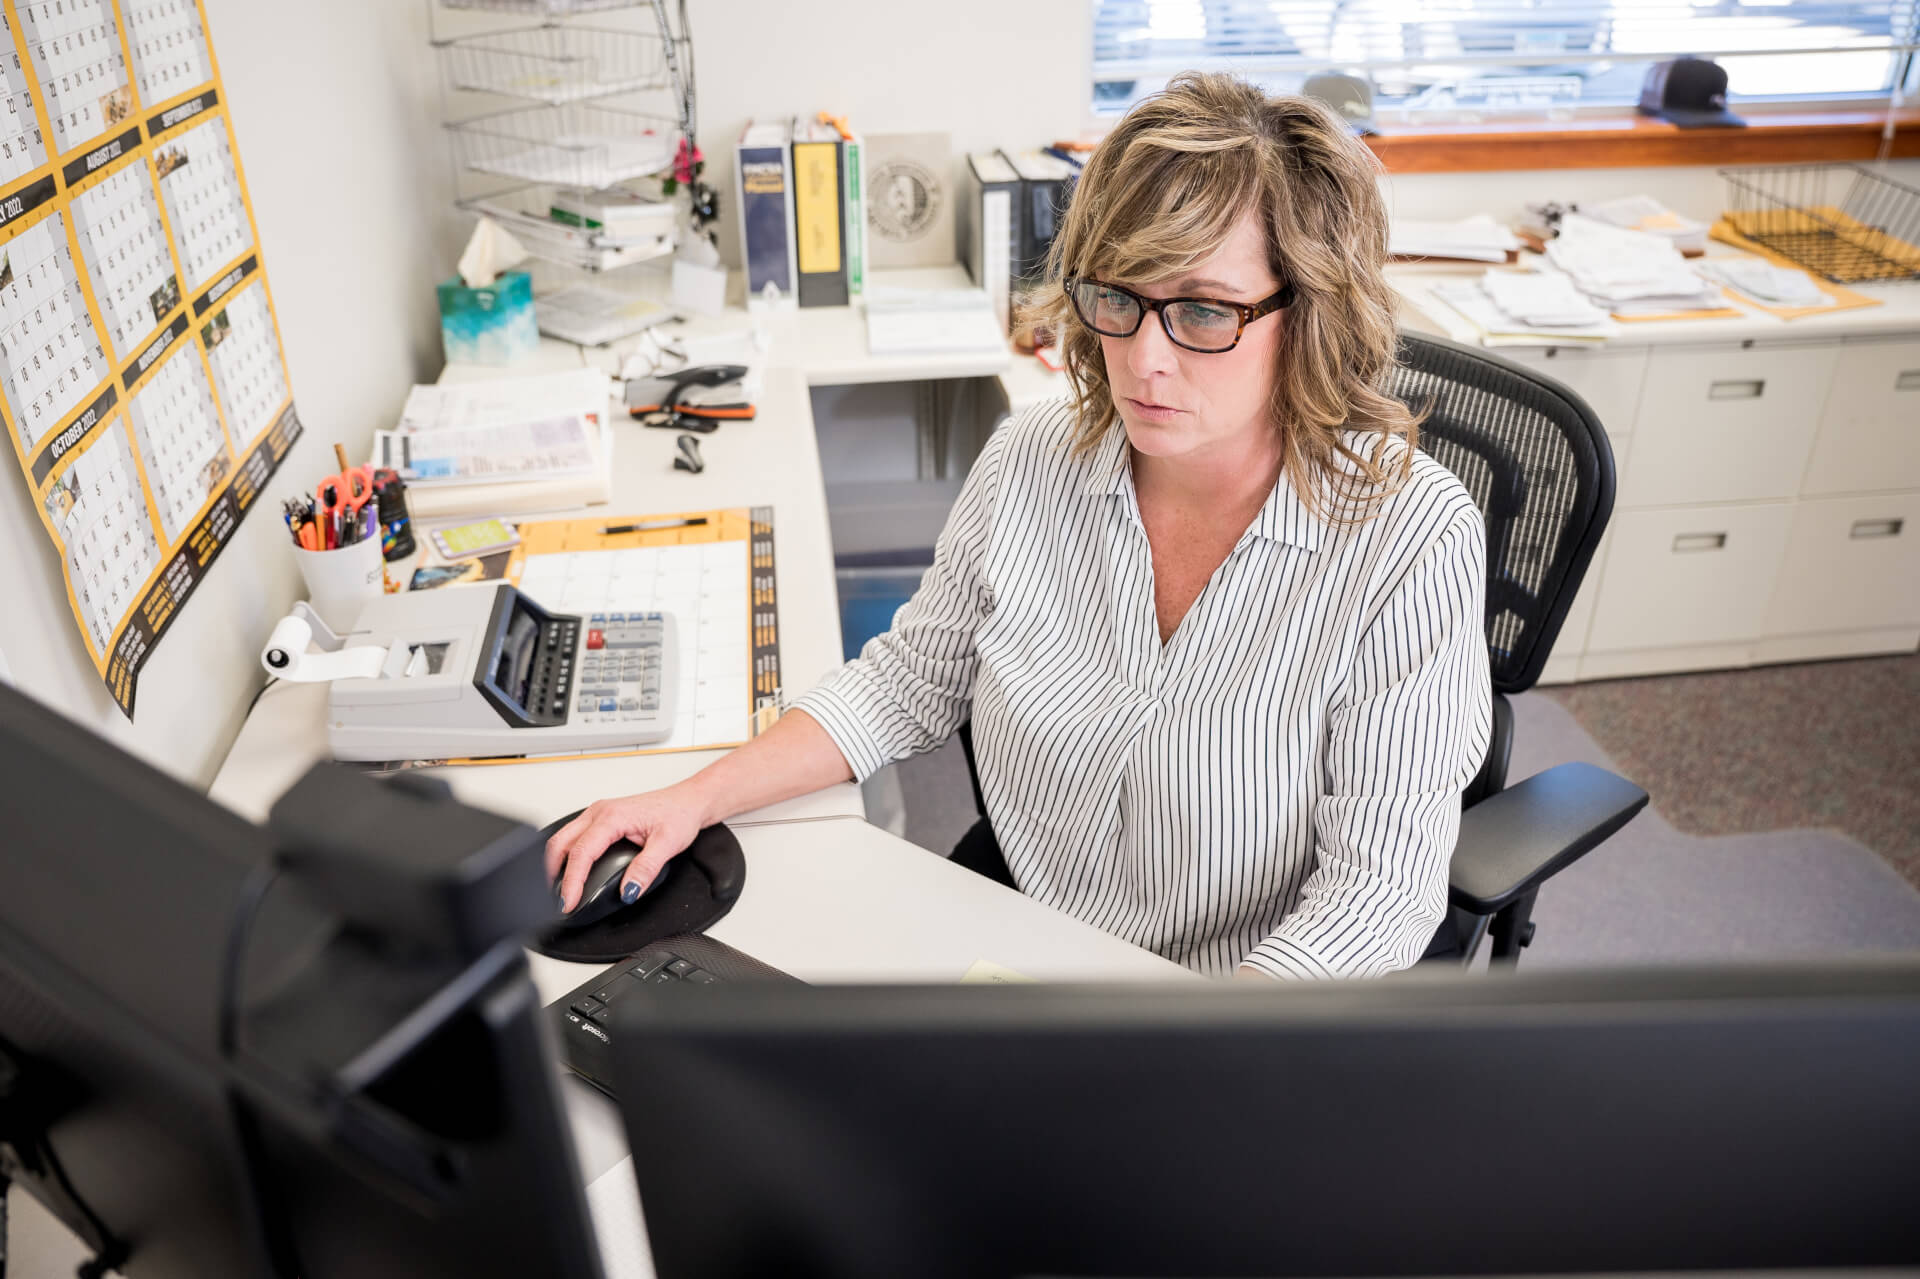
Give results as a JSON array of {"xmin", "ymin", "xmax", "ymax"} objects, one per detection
[{"xmin": 1801, "ymin": 342, "xmax": 1920, "ymax": 494}]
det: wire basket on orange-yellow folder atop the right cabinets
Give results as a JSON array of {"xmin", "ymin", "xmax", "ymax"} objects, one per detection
[{"xmin": 1720, "ymin": 165, "xmax": 1920, "ymax": 284}]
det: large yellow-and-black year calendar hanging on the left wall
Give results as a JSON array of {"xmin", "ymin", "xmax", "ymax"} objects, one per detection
[{"xmin": 0, "ymin": 0, "xmax": 301, "ymax": 716}]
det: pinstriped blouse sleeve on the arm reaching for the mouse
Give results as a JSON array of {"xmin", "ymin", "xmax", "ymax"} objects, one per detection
[{"xmin": 795, "ymin": 428, "xmax": 1008, "ymax": 782}]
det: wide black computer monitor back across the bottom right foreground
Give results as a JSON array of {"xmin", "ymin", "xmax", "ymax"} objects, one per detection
[{"xmin": 614, "ymin": 960, "xmax": 1920, "ymax": 1279}]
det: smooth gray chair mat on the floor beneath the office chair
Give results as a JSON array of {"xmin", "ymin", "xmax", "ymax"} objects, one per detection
[{"xmin": 868, "ymin": 691, "xmax": 1920, "ymax": 966}]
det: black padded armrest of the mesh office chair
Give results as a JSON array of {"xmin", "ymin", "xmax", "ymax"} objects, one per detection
[{"xmin": 1448, "ymin": 764, "xmax": 1647, "ymax": 914}]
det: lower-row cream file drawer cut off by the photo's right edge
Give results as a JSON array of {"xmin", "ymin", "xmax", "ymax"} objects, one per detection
[{"xmin": 1766, "ymin": 494, "xmax": 1920, "ymax": 636}]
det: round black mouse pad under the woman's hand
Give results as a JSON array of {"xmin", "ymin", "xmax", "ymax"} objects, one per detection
[{"xmin": 534, "ymin": 810, "xmax": 747, "ymax": 964}]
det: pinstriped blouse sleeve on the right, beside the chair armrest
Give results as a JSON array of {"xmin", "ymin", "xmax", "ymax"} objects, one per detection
[{"xmin": 1246, "ymin": 509, "xmax": 1492, "ymax": 977}]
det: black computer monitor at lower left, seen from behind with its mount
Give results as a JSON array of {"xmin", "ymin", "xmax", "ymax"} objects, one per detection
[{"xmin": 0, "ymin": 684, "xmax": 601, "ymax": 1279}]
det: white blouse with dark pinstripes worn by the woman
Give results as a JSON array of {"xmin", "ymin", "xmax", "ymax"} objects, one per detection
[{"xmin": 797, "ymin": 401, "xmax": 1492, "ymax": 977}]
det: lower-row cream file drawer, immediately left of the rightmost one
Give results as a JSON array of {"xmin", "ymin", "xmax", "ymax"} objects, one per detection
[{"xmin": 1586, "ymin": 503, "xmax": 1793, "ymax": 653}]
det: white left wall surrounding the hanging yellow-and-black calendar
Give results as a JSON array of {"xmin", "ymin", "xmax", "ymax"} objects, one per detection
[{"xmin": 0, "ymin": 0, "xmax": 453, "ymax": 782}]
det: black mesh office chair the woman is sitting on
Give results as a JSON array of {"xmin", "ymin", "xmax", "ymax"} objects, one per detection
[{"xmin": 960, "ymin": 334, "xmax": 1647, "ymax": 964}]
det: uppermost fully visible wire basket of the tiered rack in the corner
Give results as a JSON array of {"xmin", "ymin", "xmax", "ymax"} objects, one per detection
[{"xmin": 438, "ymin": 23, "xmax": 666, "ymax": 104}]
